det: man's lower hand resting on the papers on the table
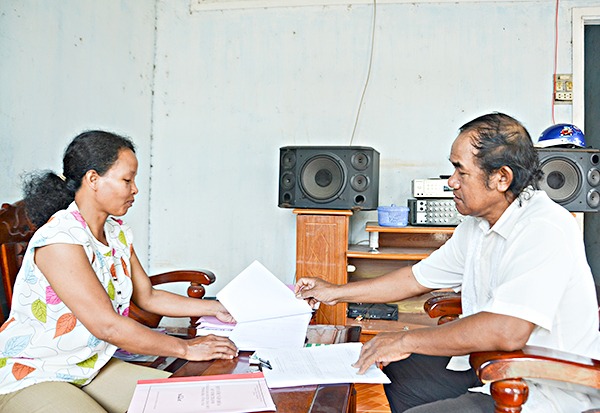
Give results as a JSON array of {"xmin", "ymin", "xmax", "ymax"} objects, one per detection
[{"xmin": 352, "ymin": 333, "xmax": 410, "ymax": 374}]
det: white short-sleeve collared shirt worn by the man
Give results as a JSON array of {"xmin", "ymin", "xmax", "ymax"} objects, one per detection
[{"xmin": 413, "ymin": 190, "xmax": 600, "ymax": 411}]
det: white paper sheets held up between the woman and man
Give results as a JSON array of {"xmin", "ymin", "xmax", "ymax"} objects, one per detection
[{"xmin": 217, "ymin": 261, "xmax": 312, "ymax": 351}]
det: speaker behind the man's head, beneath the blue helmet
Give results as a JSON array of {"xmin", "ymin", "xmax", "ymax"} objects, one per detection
[{"xmin": 537, "ymin": 148, "xmax": 600, "ymax": 212}]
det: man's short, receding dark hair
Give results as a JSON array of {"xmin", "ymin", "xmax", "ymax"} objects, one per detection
[{"xmin": 460, "ymin": 113, "xmax": 543, "ymax": 198}]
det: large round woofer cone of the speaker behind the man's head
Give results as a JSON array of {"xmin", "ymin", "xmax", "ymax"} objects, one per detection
[{"xmin": 541, "ymin": 158, "xmax": 581, "ymax": 203}]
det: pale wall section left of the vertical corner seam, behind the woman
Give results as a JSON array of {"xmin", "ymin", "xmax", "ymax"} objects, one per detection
[{"xmin": 0, "ymin": 0, "xmax": 155, "ymax": 263}]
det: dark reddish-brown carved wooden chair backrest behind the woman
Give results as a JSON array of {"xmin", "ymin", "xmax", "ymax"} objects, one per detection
[{"xmin": 0, "ymin": 201, "xmax": 35, "ymax": 321}]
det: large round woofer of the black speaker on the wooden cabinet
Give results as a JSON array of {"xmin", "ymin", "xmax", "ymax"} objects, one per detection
[{"xmin": 300, "ymin": 155, "xmax": 346, "ymax": 202}]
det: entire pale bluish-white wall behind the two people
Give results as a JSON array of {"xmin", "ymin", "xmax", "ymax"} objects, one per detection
[{"xmin": 0, "ymin": 0, "xmax": 600, "ymax": 320}]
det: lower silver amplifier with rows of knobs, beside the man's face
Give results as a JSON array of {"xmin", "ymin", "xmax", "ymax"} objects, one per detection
[{"xmin": 408, "ymin": 198, "xmax": 465, "ymax": 227}]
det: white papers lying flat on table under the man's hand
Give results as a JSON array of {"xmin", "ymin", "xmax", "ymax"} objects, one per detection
[{"xmin": 256, "ymin": 343, "xmax": 390, "ymax": 389}]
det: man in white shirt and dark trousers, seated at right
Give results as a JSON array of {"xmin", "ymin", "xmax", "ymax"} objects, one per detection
[{"xmin": 296, "ymin": 113, "xmax": 600, "ymax": 413}]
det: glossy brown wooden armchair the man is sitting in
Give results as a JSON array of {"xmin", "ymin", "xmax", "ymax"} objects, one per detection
[{"xmin": 425, "ymin": 294, "xmax": 600, "ymax": 413}]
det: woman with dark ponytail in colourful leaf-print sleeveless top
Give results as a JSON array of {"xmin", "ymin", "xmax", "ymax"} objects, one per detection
[{"xmin": 0, "ymin": 131, "xmax": 237, "ymax": 412}]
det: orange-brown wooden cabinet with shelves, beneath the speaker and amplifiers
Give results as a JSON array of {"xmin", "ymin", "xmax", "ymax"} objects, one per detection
[{"xmin": 294, "ymin": 209, "xmax": 454, "ymax": 341}]
